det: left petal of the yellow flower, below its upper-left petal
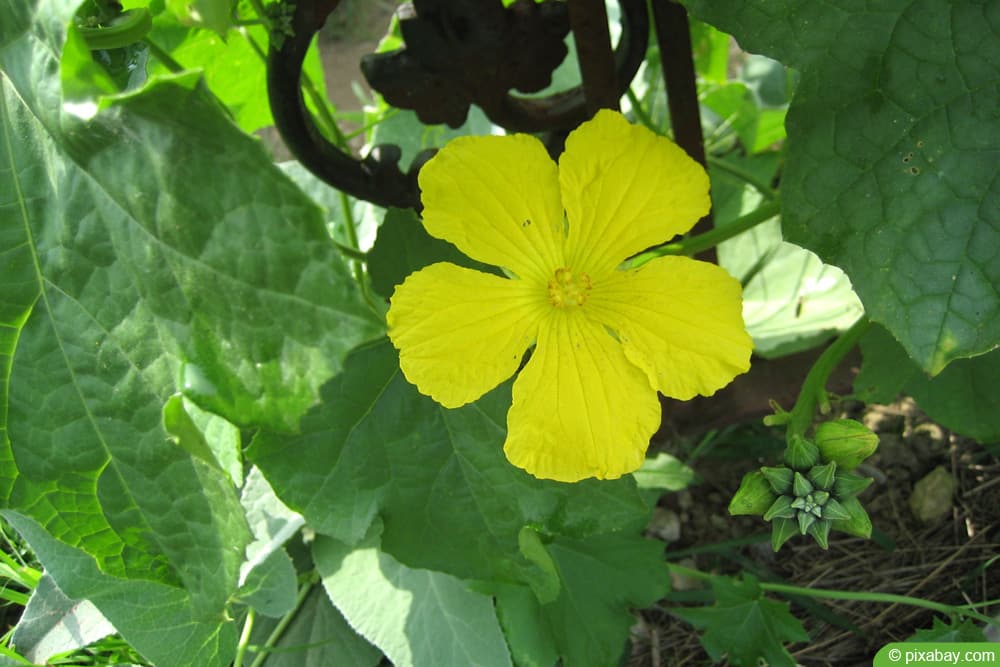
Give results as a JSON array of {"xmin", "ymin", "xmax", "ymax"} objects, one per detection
[{"xmin": 386, "ymin": 262, "xmax": 547, "ymax": 408}]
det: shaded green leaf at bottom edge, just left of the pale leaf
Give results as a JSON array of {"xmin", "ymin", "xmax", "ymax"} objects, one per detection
[{"xmin": 250, "ymin": 586, "xmax": 382, "ymax": 667}]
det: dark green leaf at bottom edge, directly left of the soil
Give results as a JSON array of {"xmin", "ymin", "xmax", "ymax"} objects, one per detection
[{"xmin": 541, "ymin": 533, "xmax": 670, "ymax": 667}]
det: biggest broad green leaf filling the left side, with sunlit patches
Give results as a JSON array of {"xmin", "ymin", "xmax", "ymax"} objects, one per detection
[{"xmin": 0, "ymin": 0, "xmax": 381, "ymax": 618}]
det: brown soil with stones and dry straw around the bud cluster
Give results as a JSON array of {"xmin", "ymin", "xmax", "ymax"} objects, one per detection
[{"xmin": 630, "ymin": 399, "xmax": 1000, "ymax": 667}]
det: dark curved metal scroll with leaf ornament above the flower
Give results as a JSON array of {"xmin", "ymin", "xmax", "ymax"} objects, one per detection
[{"xmin": 267, "ymin": 0, "xmax": 649, "ymax": 208}]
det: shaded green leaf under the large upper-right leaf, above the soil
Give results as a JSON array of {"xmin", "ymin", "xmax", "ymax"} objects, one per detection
[{"xmin": 854, "ymin": 327, "xmax": 1000, "ymax": 442}]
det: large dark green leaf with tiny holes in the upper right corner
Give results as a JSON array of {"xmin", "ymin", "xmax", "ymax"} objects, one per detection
[{"xmin": 685, "ymin": 0, "xmax": 1000, "ymax": 374}]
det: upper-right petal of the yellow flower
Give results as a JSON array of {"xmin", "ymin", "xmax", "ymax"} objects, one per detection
[{"xmin": 559, "ymin": 110, "xmax": 711, "ymax": 277}]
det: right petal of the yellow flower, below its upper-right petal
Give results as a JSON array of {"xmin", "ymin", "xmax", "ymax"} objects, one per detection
[{"xmin": 586, "ymin": 257, "xmax": 753, "ymax": 400}]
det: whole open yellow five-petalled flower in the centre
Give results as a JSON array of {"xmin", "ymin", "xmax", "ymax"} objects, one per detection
[{"xmin": 387, "ymin": 111, "xmax": 752, "ymax": 481}]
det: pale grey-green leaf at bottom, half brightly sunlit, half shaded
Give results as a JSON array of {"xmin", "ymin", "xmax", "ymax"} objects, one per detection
[{"xmin": 313, "ymin": 535, "xmax": 511, "ymax": 667}]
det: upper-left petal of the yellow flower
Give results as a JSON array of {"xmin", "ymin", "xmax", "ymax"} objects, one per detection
[{"xmin": 419, "ymin": 134, "xmax": 565, "ymax": 282}]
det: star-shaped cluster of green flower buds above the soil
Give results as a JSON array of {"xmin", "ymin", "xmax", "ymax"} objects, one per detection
[{"xmin": 729, "ymin": 419, "xmax": 878, "ymax": 551}]
